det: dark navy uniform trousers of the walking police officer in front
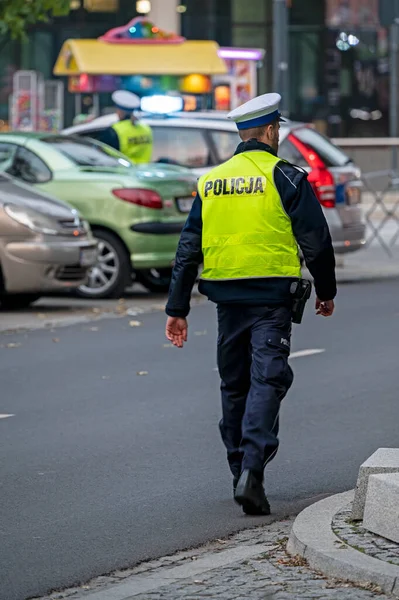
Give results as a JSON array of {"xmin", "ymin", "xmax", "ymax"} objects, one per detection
[{"xmin": 217, "ymin": 304, "xmax": 293, "ymax": 477}]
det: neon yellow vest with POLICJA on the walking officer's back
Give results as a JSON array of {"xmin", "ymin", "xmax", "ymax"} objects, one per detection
[{"xmin": 198, "ymin": 151, "xmax": 301, "ymax": 280}]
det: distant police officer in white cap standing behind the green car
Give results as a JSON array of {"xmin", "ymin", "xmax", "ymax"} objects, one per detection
[{"xmin": 101, "ymin": 90, "xmax": 152, "ymax": 163}]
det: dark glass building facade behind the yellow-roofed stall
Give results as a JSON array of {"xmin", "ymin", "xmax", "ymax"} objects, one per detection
[{"xmin": 0, "ymin": 0, "xmax": 389, "ymax": 136}]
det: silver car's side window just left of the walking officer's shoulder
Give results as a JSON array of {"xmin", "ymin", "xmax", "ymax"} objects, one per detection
[{"xmin": 152, "ymin": 126, "xmax": 211, "ymax": 168}]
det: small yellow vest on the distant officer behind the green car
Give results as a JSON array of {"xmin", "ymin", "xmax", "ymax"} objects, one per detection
[{"xmin": 112, "ymin": 119, "xmax": 152, "ymax": 163}]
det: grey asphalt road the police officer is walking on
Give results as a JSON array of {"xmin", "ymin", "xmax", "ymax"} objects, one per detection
[{"xmin": 0, "ymin": 281, "xmax": 399, "ymax": 600}]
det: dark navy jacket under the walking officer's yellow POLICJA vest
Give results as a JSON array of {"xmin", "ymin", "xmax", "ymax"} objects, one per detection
[{"xmin": 166, "ymin": 139, "xmax": 337, "ymax": 317}]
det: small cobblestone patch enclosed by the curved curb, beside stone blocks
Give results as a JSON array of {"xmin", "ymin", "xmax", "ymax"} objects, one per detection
[{"xmin": 332, "ymin": 505, "xmax": 399, "ymax": 565}]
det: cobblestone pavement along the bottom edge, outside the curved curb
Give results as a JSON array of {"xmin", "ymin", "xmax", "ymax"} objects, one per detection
[{"xmin": 36, "ymin": 519, "xmax": 391, "ymax": 600}]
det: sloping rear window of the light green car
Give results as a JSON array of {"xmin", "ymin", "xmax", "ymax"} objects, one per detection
[{"xmin": 42, "ymin": 136, "xmax": 133, "ymax": 169}]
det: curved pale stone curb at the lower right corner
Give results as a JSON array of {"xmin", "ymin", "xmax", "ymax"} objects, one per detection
[{"xmin": 287, "ymin": 491, "xmax": 399, "ymax": 598}]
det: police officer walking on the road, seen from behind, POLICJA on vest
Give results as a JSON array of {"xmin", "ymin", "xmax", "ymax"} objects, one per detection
[{"xmin": 166, "ymin": 94, "xmax": 336, "ymax": 515}]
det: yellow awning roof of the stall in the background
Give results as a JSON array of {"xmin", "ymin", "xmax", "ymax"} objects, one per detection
[{"xmin": 54, "ymin": 39, "xmax": 227, "ymax": 75}]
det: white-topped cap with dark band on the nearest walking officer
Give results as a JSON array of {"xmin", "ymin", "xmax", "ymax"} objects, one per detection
[{"xmin": 227, "ymin": 93, "xmax": 284, "ymax": 129}]
